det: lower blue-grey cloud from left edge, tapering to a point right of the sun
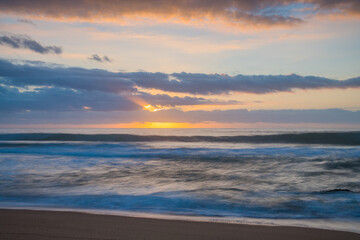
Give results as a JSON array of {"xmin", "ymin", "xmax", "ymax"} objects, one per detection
[{"xmin": 0, "ymin": 85, "xmax": 240, "ymax": 113}]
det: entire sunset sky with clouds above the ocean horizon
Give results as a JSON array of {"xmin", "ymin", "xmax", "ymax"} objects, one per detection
[{"xmin": 0, "ymin": 0, "xmax": 360, "ymax": 128}]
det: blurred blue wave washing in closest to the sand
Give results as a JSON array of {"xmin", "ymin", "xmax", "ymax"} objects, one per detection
[{"xmin": 0, "ymin": 189, "xmax": 360, "ymax": 219}]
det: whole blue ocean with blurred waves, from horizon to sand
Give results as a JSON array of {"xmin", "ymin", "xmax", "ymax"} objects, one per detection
[{"xmin": 0, "ymin": 129, "xmax": 360, "ymax": 231}]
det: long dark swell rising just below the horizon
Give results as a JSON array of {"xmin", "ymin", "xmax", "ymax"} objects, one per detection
[{"xmin": 0, "ymin": 132, "xmax": 360, "ymax": 146}]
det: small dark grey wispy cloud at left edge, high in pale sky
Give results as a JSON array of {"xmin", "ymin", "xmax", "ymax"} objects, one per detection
[{"xmin": 0, "ymin": 34, "xmax": 62, "ymax": 54}]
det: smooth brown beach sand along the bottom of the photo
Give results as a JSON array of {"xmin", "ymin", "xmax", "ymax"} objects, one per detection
[{"xmin": 0, "ymin": 209, "xmax": 360, "ymax": 240}]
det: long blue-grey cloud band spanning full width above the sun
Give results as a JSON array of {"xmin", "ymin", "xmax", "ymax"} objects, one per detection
[{"xmin": 0, "ymin": 59, "xmax": 360, "ymax": 95}]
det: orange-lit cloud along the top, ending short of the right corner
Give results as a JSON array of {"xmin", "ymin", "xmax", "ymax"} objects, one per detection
[{"xmin": 0, "ymin": 0, "xmax": 310, "ymax": 27}]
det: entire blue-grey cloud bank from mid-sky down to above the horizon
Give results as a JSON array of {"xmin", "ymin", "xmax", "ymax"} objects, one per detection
[{"xmin": 0, "ymin": 60, "xmax": 360, "ymax": 124}]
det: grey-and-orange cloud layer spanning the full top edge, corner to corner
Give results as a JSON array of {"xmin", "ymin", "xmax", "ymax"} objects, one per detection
[{"xmin": 0, "ymin": 0, "xmax": 360, "ymax": 26}]
